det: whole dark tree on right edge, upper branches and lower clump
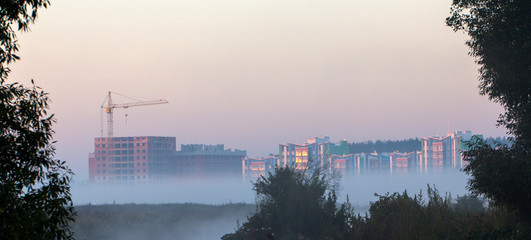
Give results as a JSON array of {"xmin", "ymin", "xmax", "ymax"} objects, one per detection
[{"xmin": 446, "ymin": 0, "xmax": 531, "ymax": 222}]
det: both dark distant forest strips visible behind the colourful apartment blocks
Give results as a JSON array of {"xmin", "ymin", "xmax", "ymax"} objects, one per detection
[{"xmin": 349, "ymin": 137, "xmax": 512, "ymax": 153}]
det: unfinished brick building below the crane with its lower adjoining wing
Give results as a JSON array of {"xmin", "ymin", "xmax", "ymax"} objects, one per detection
[{"xmin": 89, "ymin": 136, "xmax": 247, "ymax": 183}]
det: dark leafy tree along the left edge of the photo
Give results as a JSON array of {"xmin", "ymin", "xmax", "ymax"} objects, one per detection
[{"xmin": 0, "ymin": 0, "xmax": 75, "ymax": 239}]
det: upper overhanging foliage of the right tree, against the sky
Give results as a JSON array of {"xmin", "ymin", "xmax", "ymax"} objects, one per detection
[{"xmin": 446, "ymin": 0, "xmax": 531, "ymax": 141}]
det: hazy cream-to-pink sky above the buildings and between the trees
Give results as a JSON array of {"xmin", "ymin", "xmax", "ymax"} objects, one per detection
[{"xmin": 10, "ymin": 0, "xmax": 505, "ymax": 180}]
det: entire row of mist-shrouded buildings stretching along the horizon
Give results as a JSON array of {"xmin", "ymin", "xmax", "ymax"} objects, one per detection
[{"xmin": 88, "ymin": 131, "xmax": 483, "ymax": 184}]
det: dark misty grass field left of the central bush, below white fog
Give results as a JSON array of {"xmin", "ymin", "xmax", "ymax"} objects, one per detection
[{"xmin": 73, "ymin": 203, "xmax": 255, "ymax": 240}]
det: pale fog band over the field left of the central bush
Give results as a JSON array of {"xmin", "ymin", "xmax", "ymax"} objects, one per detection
[{"xmin": 72, "ymin": 178, "xmax": 254, "ymax": 205}]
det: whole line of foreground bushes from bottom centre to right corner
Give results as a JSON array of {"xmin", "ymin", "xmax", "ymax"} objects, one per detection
[{"xmin": 222, "ymin": 167, "xmax": 531, "ymax": 240}]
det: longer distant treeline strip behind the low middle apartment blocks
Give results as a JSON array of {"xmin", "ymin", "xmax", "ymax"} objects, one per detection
[{"xmin": 349, "ymin": 138, "xmax": 420, "ymax": 153}]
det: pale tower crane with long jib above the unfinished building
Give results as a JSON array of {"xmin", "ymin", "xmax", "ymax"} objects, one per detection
[{"xmin": 101, "ymin": 91, "xmax": 168, "ymax": 138}]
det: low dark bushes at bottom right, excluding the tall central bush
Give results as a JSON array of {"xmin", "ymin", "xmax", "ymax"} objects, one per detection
[{"xmin": 356, "ymin": 186, "xmax": 530, "ymax": 239}]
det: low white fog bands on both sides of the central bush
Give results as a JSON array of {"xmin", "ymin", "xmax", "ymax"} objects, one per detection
[{"xmin": 71, "ymin": 170, "xmax": 467, "ymax": 206}]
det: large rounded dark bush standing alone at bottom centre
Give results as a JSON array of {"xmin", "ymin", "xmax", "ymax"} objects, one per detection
[{"xmin": 222, "ymin": 167, "xmax": 354, "ymax": 240}]
